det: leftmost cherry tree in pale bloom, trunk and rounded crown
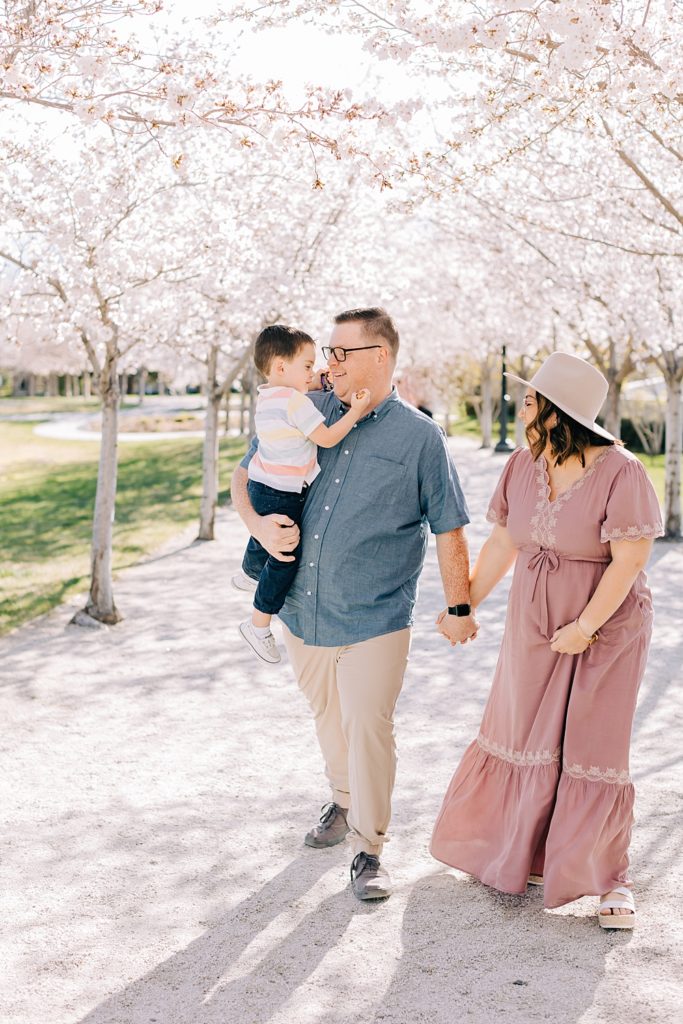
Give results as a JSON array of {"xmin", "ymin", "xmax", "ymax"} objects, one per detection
[{"xmin": 0, "ymin": 128, "xmax": 210, "ymax": 623}]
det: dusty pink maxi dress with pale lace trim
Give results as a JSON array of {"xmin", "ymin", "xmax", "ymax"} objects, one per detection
[{"xmin": 431, "ymin": 445, "xmax": 664, "ymax": 907}]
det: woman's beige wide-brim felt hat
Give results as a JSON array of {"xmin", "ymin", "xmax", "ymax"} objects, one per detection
[{"xmin": 505, "ymin": 352, "xmax": 616, "ymax": 441}]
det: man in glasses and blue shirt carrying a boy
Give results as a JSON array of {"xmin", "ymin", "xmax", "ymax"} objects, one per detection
[{"xmin": 232, "ymin": 308, "xmax": 477, "ymax": 899}]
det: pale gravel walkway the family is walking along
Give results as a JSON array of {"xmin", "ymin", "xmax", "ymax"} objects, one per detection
[{"xmin": 0, "ymin": 449, "xmax": 683, "ymax": 1024}]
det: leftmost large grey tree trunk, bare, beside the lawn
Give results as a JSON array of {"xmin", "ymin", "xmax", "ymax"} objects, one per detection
[{"xmin": 85, "ymin": 351, "xmax": 122, "ymax": 624}]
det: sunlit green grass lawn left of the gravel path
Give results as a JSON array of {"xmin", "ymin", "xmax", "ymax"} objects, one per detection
[{"xmin": 0, "ymin": 422, "xmax": 245, "ymax": 634}]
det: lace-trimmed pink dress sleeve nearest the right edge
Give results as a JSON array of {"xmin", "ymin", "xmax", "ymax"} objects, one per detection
[{"xmin": 600, "ymin": 453, "xmax": 664, "ymax": 544}]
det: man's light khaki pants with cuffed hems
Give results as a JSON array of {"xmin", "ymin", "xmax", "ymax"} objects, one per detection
[{"xmin": 283, "ymin": 626, "xmax": 411, "ymax": 855}]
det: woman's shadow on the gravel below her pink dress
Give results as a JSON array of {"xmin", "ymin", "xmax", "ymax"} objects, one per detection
[{"xmin": 370, "ymin": 871, "xmax": 610, "ymax": 1024}]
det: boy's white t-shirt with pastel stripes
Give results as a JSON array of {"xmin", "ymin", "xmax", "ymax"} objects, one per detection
[{"xmin": 249, "ymin": 384, "xmax": 325, "ymax": 494}]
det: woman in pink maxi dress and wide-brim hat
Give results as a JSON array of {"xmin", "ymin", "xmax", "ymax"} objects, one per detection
[{"xmin": 431, "ymin": 352, "xmax": 664, "ymax": 928}]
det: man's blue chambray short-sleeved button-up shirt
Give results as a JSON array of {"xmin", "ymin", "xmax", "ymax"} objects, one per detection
[{"xmin": 241, "ymin": 388, "xmax": 470, "ymax": 647}]
